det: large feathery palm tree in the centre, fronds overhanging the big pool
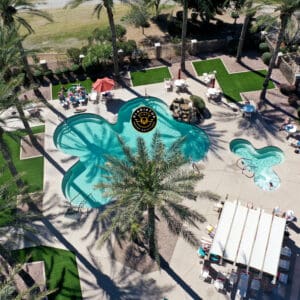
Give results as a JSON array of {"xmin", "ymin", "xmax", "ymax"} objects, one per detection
[{"xmin": 97, "ymin": 133, "xmax": 217, "ymax": 264}]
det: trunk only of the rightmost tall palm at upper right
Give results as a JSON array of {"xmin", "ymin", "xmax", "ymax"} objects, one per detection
[{"xmin": 260, "ymin": 14, "xmax": 290, "ymax": 101}]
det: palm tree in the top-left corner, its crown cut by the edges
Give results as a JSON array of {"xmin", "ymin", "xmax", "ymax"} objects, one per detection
[{"xmin": 0, "ymin": 0, "xmax": 52, "ymax": 83}]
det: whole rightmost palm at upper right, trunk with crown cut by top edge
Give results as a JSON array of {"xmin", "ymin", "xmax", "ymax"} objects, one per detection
[{"xmin": 256, "ymin": 0, "xmax": 300, "ymax": 101}]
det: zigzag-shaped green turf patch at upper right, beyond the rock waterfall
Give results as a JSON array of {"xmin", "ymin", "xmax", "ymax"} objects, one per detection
[{"xmin": 193, "ymin": 59, "xmax": 274, "ymax": 102}]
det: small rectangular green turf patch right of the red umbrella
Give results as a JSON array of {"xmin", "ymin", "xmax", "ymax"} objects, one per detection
[{"xmin": 130, "ymin": 67, "xmax": 172, "ymax": 86}]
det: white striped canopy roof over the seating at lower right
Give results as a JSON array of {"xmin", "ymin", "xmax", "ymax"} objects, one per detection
[{"xmin": 210, "ymin": 202, "xmax": 286, "ymax": 276}]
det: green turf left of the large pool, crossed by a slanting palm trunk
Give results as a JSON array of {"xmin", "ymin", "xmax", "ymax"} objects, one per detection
[{"xmin": 0, "ymin": 126, "xmax": 45, "ymax": 192}]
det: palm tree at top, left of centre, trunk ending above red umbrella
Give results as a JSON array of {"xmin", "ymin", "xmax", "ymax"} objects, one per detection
[{"xmin": 66, "ymin": 0, "xmax": 120, "ymax": 80}]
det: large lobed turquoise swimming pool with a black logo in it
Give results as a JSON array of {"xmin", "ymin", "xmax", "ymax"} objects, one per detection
[{"xmin": 53, "ymin": 97, "xmax": 209, "ymax": 208}]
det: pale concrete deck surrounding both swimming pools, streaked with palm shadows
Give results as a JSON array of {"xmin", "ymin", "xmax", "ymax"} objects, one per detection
[{"xmin": 3, "ymin": 56, "xmax": 300, "ymax": 300}]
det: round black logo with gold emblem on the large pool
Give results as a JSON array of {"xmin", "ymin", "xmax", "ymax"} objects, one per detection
[{"xmin": 131, "ymin": 106, "xmax": 157, "ymax": 132}]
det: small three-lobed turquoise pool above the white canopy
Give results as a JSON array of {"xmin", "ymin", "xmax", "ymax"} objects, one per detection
[{"xmin": 230, "ymin": 139, "xmax": 284, "ymax": 191}]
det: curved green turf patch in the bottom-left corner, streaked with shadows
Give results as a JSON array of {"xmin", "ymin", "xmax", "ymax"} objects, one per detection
[{"xmin": 13, "ymin": 246, "xmax": 82, "ymax": 300}]
